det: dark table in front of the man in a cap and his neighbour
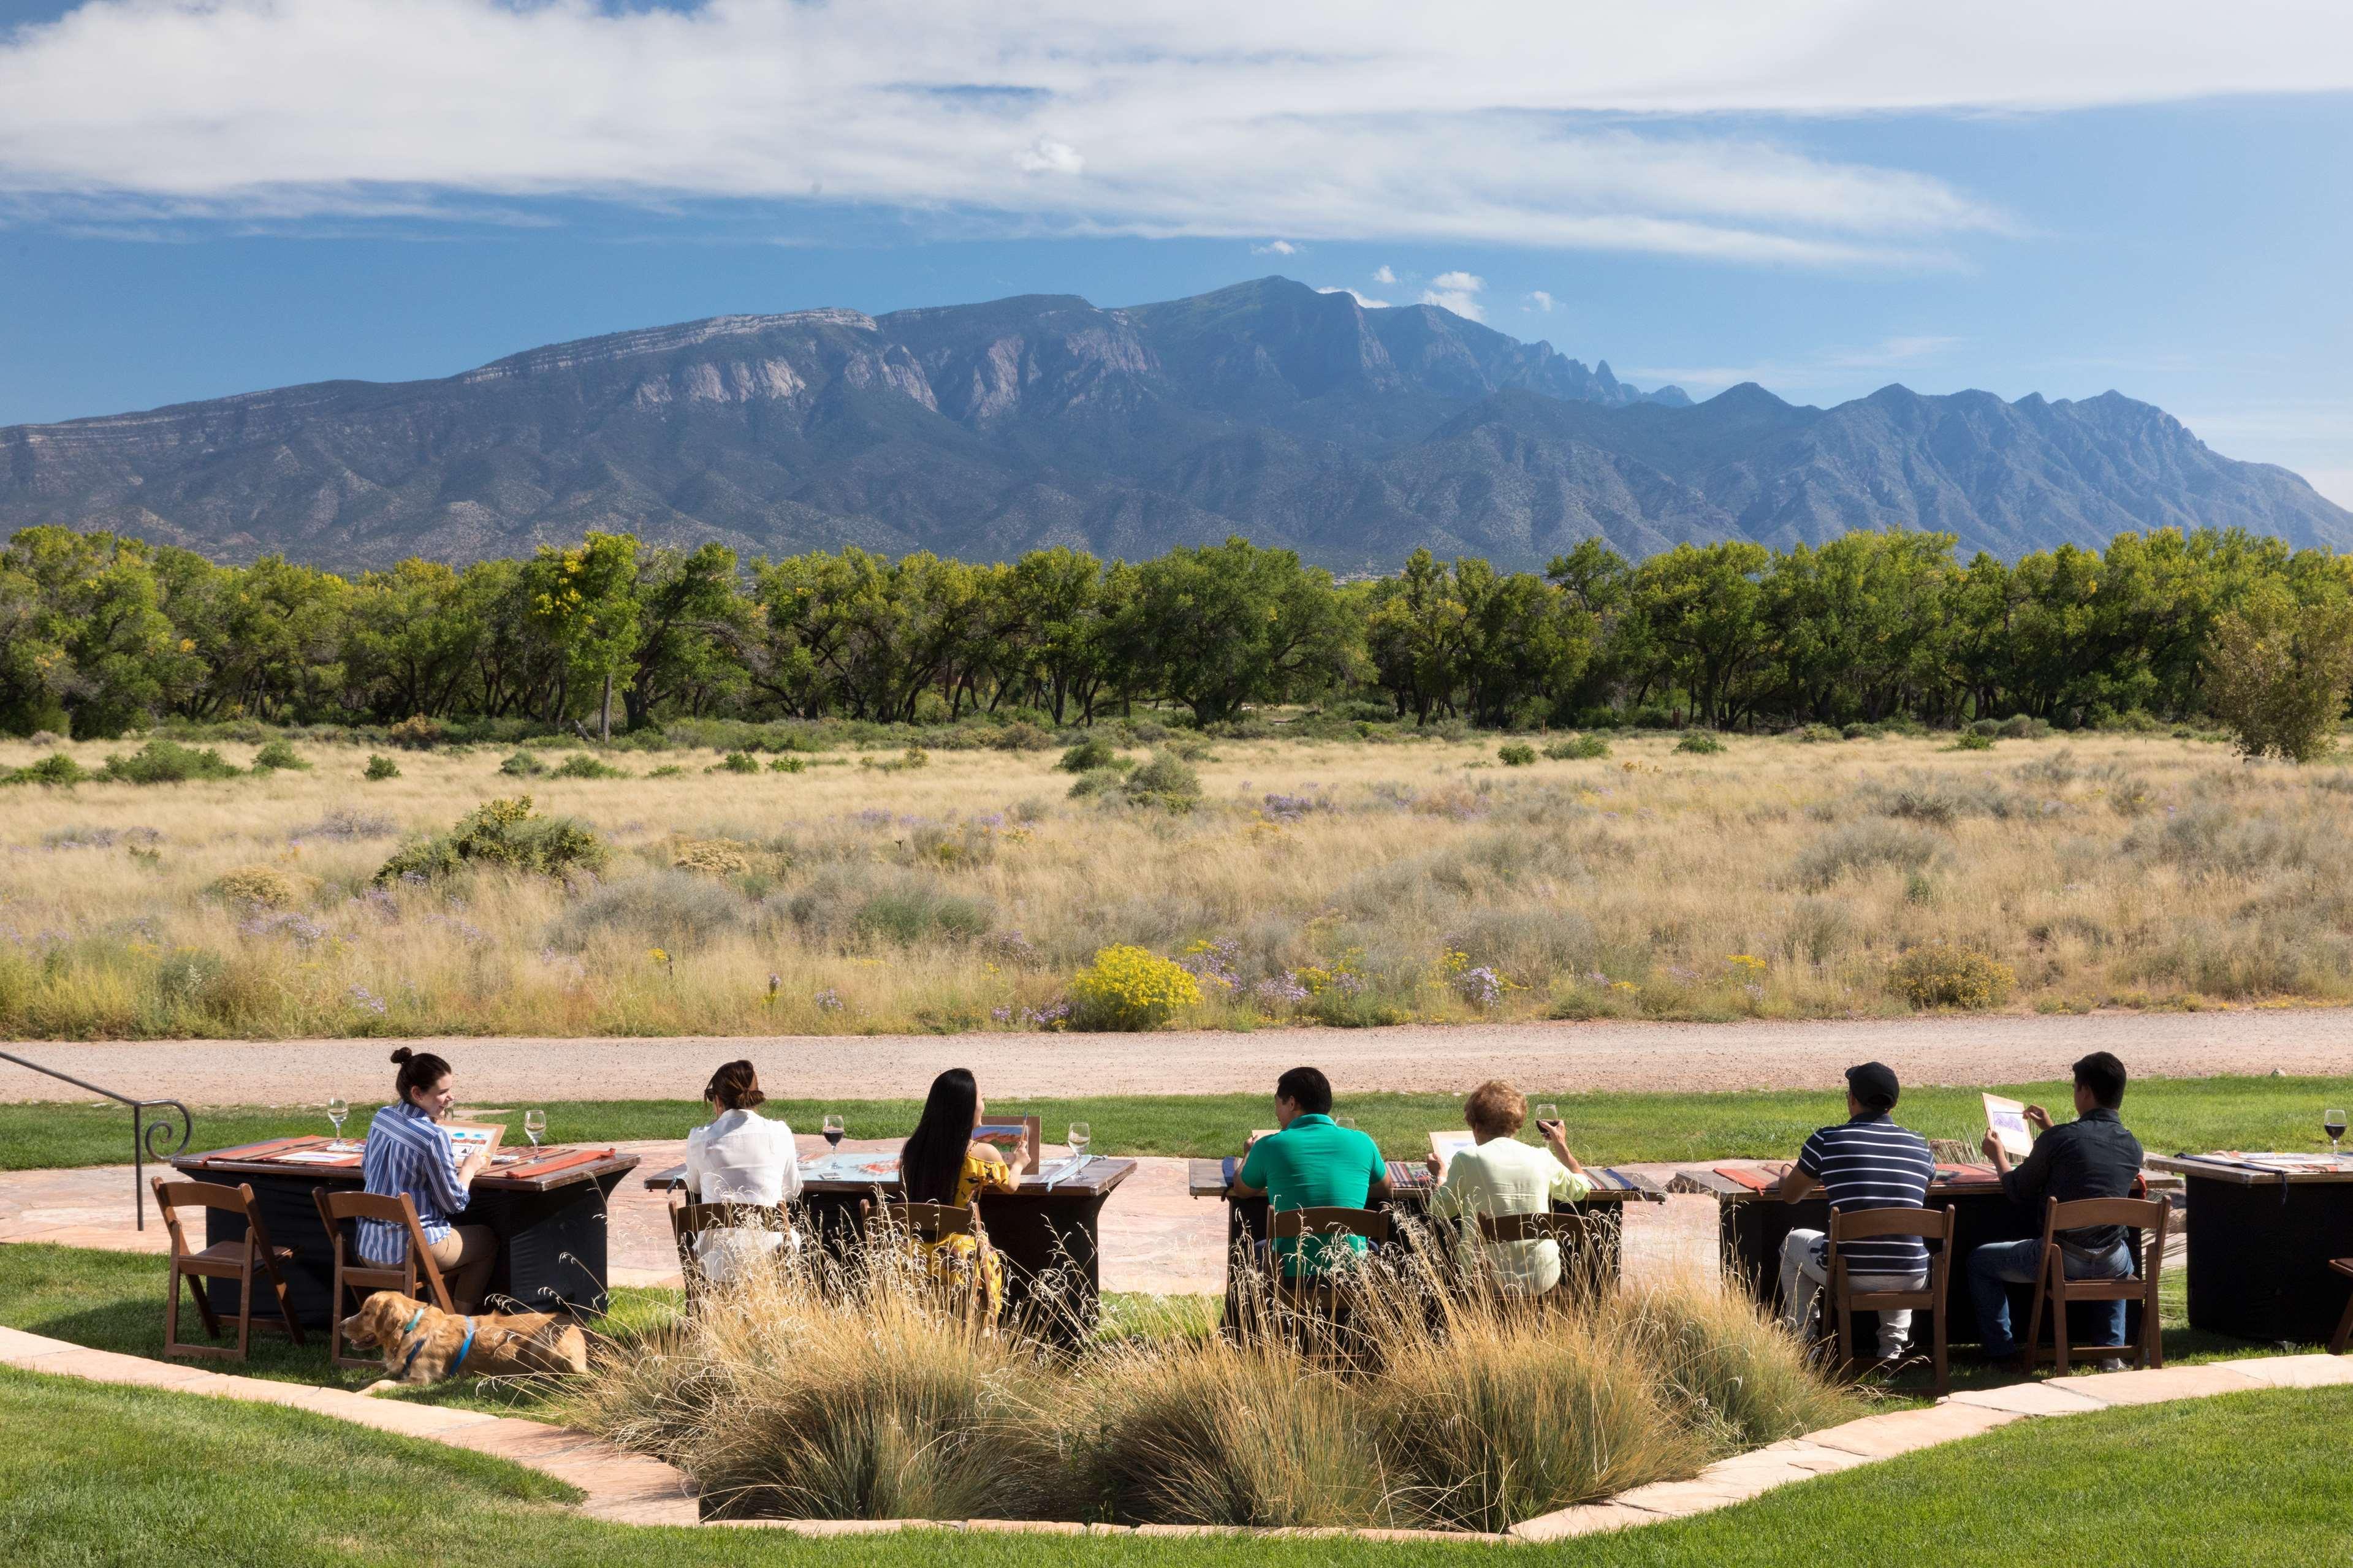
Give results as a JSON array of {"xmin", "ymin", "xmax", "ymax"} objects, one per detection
[{"xmin": 1668, "ymin": 1161, "xmax": 2141, "ymax": 1345}]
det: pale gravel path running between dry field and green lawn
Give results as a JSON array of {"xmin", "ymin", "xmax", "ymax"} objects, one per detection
[{"xmin": 0, "ymin": 1009, "xmax": 2353, "ymax": 1105}]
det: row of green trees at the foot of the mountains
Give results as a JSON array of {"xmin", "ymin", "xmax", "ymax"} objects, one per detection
[{"xmin": 0, "ymin": 526, "xmax": 2353, "ymax": 738}]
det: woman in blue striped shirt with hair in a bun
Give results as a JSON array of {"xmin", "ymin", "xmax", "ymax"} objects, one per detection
[{"xmin": 358, "ymin": 1046, "xmax": 499, "ymax": 1312}]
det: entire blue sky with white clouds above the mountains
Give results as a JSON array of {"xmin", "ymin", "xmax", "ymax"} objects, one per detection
[{"xmin": 0, "ymin": 0, "xmax": 2353, "ymax": 506}]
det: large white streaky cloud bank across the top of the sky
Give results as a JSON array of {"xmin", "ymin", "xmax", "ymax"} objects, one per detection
[{"xmin": 0, "ymin": 0, "xmax": 2353, "ymax": 266}]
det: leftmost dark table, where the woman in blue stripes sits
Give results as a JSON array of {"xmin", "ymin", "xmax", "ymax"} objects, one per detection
[{"xmin": 172, "ymin": 1138, "xmax": 637, "ymax": 1328}]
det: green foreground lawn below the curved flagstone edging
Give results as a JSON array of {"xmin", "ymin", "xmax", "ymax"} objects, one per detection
[{"xmin": 0, "ymin": 1368, "xmax": 2353, "ymax": 1568}]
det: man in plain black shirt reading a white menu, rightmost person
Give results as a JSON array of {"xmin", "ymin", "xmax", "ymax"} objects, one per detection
[{"xmin": 1969, "ymin": 1051, "xmax": 2141, "ymax": 1368}]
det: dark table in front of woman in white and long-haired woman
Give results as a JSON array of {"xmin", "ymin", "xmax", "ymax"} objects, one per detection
[{"xmin": 645, "ymin": 1154, "xmax": 1136, "ymax": 1331}]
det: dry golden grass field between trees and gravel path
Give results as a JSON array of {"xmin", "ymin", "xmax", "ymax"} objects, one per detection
[{"xmin": 0, "ymin": 736, "xmax": 2353, "ymax": 1037}]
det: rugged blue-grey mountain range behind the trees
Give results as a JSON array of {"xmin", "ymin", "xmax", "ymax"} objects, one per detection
[{"xmin": 0, "ymin": 278, "xmax": 2353, "ymax": 571}]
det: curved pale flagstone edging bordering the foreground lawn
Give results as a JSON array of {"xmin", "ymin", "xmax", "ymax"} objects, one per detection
[{"xmin": 0, "ymin": 1328, "xmax": 2353, "ymax": 1545}]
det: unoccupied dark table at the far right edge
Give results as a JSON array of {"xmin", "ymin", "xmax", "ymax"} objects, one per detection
[{"xmin": 2148, "ymin": 1154, "xmax": 2353, "ymax": 1345}]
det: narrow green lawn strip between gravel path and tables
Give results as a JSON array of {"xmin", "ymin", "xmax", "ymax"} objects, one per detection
[{"xmin": 0, "ymin": 1060, "xmax": 2353, "ymax": 1171}]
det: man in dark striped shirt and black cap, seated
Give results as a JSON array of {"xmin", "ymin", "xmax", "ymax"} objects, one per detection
[{"xmin": 1781, "ymin": 1062, "xmax": 1936, "ymax": 1363}]
